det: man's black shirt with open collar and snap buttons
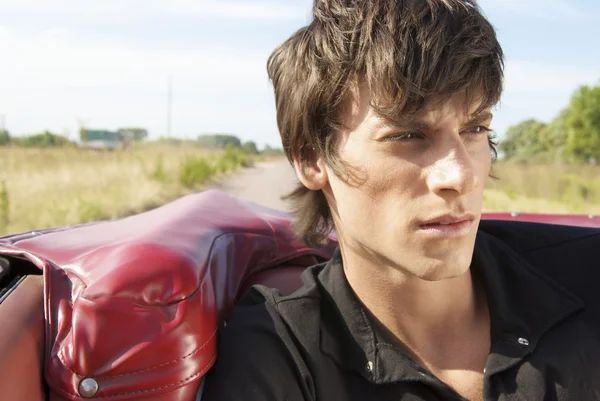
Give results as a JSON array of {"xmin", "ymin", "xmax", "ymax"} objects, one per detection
[{"xmin": 202, "ymin": 221, "xmax": 600, "ymax": 401}]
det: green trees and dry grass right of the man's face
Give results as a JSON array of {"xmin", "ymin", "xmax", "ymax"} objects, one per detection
[{"xmin": 484, "ymin": 81, "xmax": 600, "ymax": 215}]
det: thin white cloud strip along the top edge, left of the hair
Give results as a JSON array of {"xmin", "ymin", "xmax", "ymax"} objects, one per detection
[{"xmin": 0, "ymin": 0, "xmax": 307, "ymax": 22}]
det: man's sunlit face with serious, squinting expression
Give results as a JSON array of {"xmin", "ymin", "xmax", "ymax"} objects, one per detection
[{"xmin": 323, "ymin": 89, "xmax": 492, "ymax": 280}]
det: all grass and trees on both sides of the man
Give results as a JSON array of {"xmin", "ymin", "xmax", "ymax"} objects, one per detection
[{"xmin": 0, "ymin": 78, "xmax": 600, "ymax": 234}]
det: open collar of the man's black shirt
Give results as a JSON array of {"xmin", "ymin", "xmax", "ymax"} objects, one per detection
[{"xmin": 317, "ymin": 231, "xmax": 583, "ymax": 383}]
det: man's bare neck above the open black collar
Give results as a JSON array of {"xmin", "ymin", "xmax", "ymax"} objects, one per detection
[{"xmin": 343, "ymin": 247, "xmax": 489, "ymax": 369}]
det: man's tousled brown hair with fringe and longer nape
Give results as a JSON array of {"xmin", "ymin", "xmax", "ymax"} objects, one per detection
[{"xmin": 267, "ymin": 0, "xmax": 504, "ymax": 245}]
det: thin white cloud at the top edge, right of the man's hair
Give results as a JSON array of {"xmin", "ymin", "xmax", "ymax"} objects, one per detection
[{"xmin": 480, "ymin": 0, "xmax": 588, "ymax": 21}]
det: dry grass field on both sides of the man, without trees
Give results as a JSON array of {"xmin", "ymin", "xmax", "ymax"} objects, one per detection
[{"xmin": 0, "ymin": 151, "xmax": 600, "ymax": 238}]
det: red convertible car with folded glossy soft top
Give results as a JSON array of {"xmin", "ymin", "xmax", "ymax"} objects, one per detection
[{"xmin": 0, "ymin": 190, "xmax": 600, "ymax": 401}]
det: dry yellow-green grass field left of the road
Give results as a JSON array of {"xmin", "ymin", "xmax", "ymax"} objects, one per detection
[{"xmin": 0, "ymin": 145, "xmax": 249, "ymax": 233}]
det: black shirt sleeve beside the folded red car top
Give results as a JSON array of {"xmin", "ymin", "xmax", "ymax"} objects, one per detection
[{"xmin": 202, "ymin": 290, "xmax": 313, "ymax": 401}]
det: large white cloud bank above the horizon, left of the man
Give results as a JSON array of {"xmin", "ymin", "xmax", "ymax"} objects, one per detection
[{"xmin": 0, "ymin": 23, "xmax": 277, "ymax": 143}]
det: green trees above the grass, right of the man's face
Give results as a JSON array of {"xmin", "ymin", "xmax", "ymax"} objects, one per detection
[{"xmin": 499, "ymin": 82, "xmax": 600, "ymax": 164}]
